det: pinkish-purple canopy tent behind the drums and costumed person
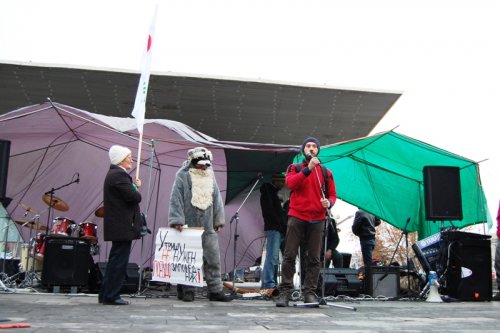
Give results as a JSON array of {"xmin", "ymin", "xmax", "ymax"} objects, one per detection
[{"xmin": 0, "ymin": 102, "xmax": 297, "ymax": 272}]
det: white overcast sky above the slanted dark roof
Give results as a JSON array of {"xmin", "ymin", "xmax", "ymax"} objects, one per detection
[{"xmin": 0, "ymin": 0, "xmax": 500, "ymax": 228}]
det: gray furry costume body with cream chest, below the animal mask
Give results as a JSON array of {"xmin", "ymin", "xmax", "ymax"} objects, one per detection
[{"xmin": 168, "ymin": 158, "xmax": 225, "ymax": 293}]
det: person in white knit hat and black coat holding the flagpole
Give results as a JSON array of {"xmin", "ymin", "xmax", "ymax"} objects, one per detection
[{"xmin": 99, "ymin": 145, "xmax": 143, "ymax": 305}]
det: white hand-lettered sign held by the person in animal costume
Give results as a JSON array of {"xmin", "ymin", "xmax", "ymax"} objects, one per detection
[{"xmin": 152, "ymin": 228, "xmax": 203, "ymax": 287}]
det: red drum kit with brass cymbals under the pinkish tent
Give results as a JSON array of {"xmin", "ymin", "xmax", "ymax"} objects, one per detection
[{"xmin": 4, "ymin": 194, "xmax": 104, "ymax": 287}]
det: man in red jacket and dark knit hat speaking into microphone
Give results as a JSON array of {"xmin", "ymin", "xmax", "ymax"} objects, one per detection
[{"xmin": 276, "ymin": 137, "xmax": 337, "ymax": 307}]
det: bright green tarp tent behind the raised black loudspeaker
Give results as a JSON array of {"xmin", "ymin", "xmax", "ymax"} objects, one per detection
[{"xmin": 310, "ymin": 131, "xmax": 491, "ymax": 239}]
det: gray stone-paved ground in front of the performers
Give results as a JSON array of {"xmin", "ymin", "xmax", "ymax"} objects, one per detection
[{"xmin": 0, "ymin": 282, "xmax": 500, "ymax": 333}]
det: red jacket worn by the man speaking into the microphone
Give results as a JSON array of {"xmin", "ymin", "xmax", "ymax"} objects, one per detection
[{"xmin": 286, "ymin": 161, "xmax": 337, "ymax": 221}]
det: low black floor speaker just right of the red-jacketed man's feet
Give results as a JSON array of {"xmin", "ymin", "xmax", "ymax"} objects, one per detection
[{"xmin": 318, "ymin": 268, "xmax": 362, "ymax": 297}]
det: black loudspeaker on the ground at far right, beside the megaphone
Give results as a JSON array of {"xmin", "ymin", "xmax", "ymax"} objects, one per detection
[{"xmin": 441, "ymin": 238, "xmax": 492, "ymax": 301}]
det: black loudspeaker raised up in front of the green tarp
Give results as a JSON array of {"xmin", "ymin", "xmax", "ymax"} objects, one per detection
[{"xmin": 424, "ymin": 166, "xmax": 463, "ymax": 221}]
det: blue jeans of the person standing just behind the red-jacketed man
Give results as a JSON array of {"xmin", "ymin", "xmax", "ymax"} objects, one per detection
[{"xmin": 262, "ymin": 230, "xmax": 285, "ymax": 289}]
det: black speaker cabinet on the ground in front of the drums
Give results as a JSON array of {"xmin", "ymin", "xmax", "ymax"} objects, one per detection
[{"xmin": 42, "ymin": 236, "xmax": 92, "ymax": 287}]
